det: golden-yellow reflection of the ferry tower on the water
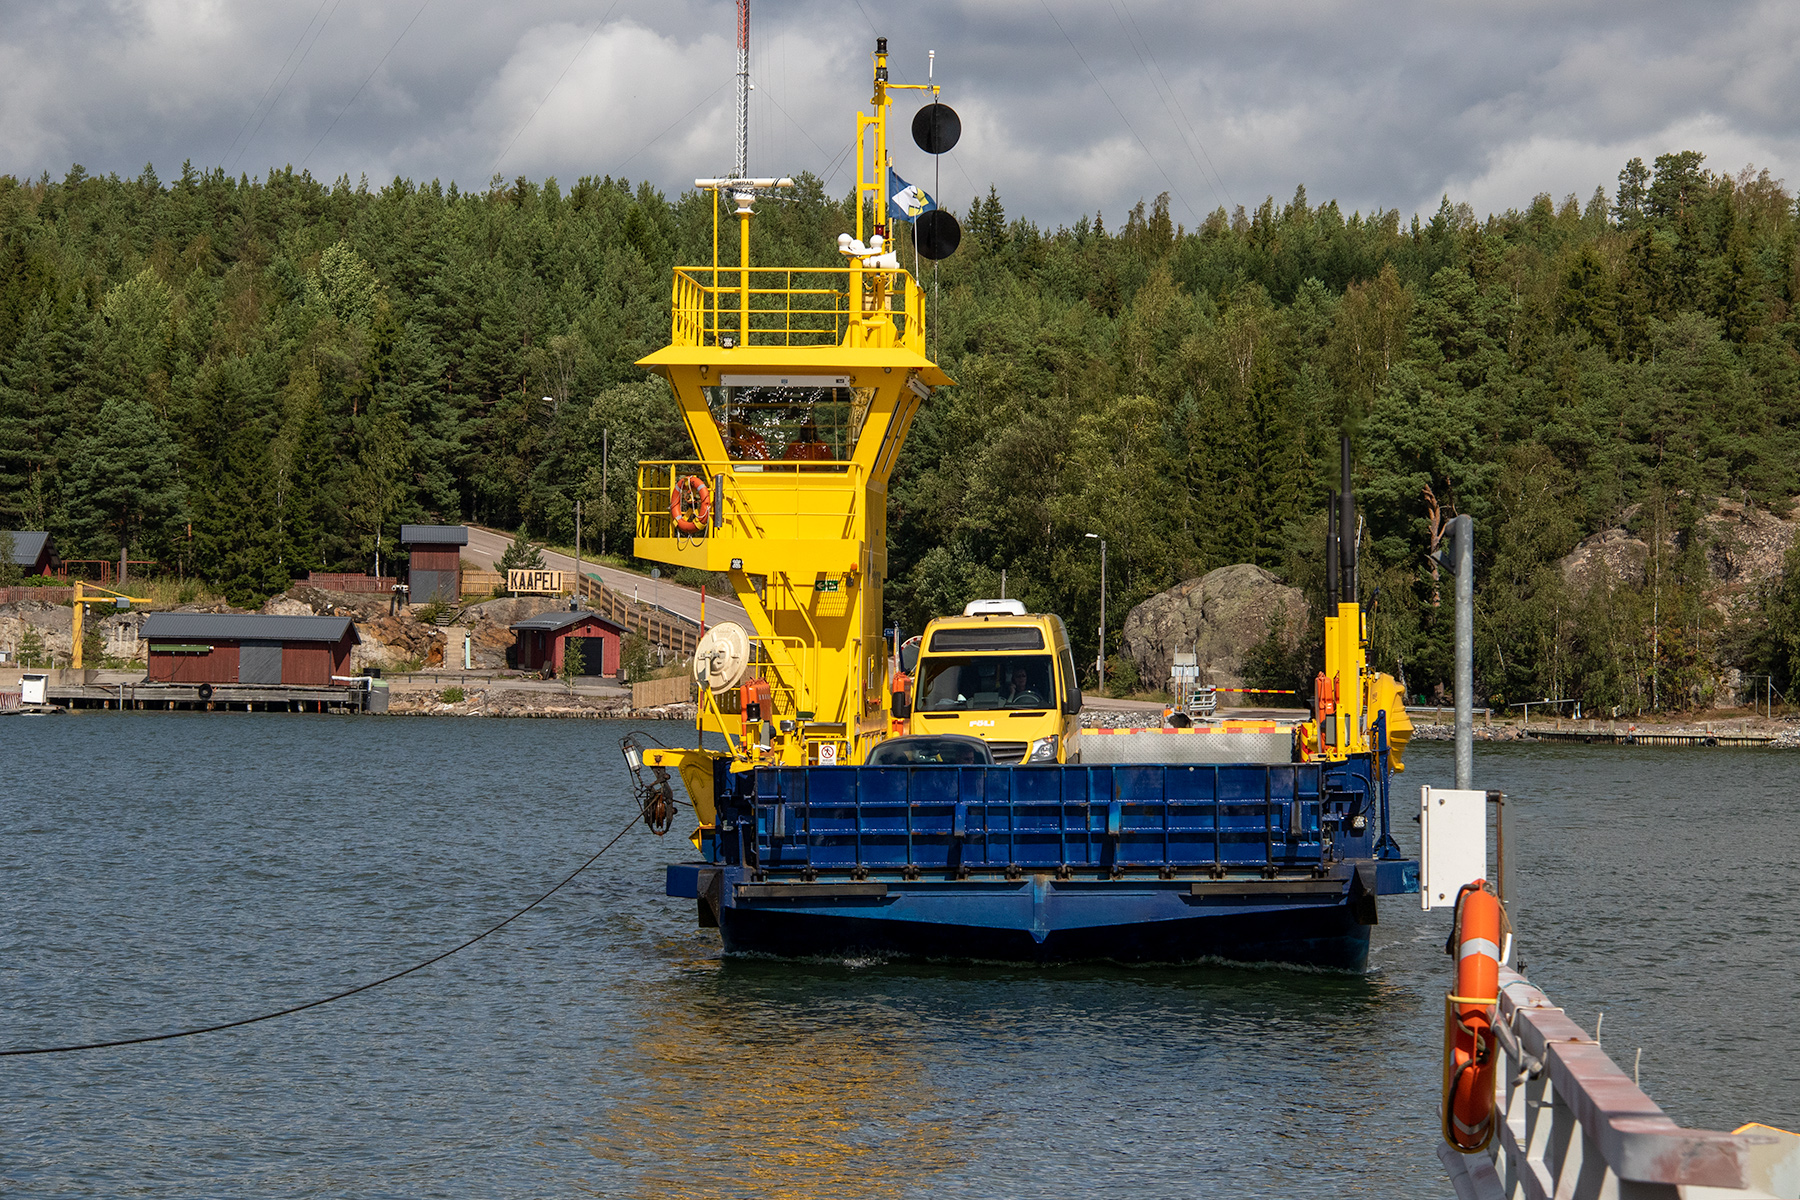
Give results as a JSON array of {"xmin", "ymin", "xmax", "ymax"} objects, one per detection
[{"xmin": 581, "ymin": 964, "xmax": 979, "ymax": 1200}]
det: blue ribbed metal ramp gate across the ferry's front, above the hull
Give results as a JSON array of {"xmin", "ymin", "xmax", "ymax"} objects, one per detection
[{"xmin": 743, "ymin": 763, "xmax": 1348, "ymax": 871}]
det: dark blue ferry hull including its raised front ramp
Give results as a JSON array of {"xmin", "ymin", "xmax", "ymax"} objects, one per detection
[{"xmin": 666, "ymin": 756, "xmax": 1418, "ymax": 972}]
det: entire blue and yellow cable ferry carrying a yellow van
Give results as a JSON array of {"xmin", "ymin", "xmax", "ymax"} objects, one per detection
[{"xmin": 625, "ymin": 27, "xmax": 1418, "ymax": 970}]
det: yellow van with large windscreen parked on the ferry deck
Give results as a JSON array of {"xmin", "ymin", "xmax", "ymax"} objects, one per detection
[{"xmin": 893, "ymin": 599, "xmax": 1082, "ymax": 763}]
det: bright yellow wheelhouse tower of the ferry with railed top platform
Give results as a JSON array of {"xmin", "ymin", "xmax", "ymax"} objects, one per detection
[{"xmin": 634, "ymin": 31, "xmax": 950, "ymax": 780}]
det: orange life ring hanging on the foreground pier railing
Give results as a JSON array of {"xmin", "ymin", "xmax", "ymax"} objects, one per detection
[{"xmin": 1444, "ymin": 880, "xmax": 1505, "ymax": 1155}]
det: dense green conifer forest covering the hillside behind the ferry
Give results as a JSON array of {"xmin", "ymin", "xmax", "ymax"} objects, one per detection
[{"xmin": 0, "ymin": 151, "xmax": 1800, "ymax": 712}]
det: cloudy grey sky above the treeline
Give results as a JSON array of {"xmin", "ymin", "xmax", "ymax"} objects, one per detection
[{"xmin": 0, "ymin": 0, "xmax": 1800, "ymax": 225}]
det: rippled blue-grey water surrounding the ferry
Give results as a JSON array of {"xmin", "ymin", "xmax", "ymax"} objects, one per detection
[{"xmin": 0, "ymin": 712, "xmax": 1800, "ymax": 1198}]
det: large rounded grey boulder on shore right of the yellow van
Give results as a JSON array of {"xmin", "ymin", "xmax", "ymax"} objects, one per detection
[{"xmin": 1125, "ymin": 563, "xmax": 1309, "ymax": 687}]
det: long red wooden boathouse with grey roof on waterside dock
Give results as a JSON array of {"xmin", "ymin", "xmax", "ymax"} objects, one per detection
[{"xmin": 139, "ymin": 612, "xmax": 362, "ymax": 687}]
